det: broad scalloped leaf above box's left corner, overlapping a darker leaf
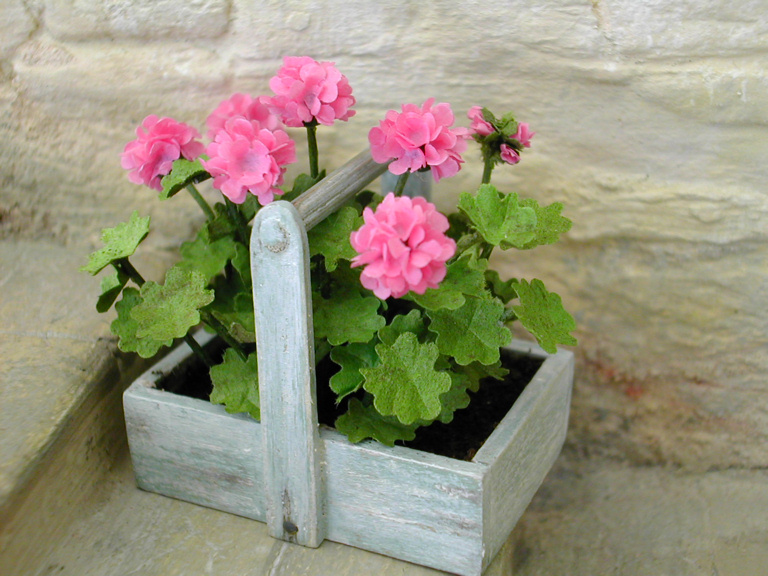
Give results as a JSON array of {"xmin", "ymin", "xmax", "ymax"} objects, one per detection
[{"xmin": 131, "ymin": 266, "xmax": 213, "ymax": 340}]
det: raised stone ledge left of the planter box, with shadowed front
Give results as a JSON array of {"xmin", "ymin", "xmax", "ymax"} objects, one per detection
[{"xmin": 0, "ymin": 241, "xmax": 148, "ymax": 574}]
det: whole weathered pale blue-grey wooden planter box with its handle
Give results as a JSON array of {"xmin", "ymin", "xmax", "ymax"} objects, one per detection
[{"xmin": 124, "ymin": 154, "xmax": 573, "ymax": 576}]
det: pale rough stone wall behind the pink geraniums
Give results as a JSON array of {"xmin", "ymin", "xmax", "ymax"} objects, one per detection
[{"xmin": 0, "ymin": 0, "xmax": 768, "ymax": 468}]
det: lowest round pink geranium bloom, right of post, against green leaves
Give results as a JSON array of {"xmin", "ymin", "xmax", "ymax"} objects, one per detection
[{"xmin": 350, "ymin": 192, "xmax": 456, "ymax": 300}]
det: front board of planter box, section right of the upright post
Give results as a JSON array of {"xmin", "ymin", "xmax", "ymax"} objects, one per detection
[{"xmin": 322, "ymin": 429, "xmax": 487, "ymax": 576}]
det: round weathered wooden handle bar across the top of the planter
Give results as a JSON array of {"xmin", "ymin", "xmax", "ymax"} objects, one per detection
[{"xmin": 293, "ymin": 149, "xmax": 388, "ymax": 230}]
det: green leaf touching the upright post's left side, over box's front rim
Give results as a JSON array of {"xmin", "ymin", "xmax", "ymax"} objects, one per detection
[{"xmin": 211, "ymin": 348, "xmax": 261, "ymax": 420}]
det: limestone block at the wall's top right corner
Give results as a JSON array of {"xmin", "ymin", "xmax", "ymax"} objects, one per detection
[{"xmin": 593, "ymin": 0, "xmax": 768, "ymax": 61}]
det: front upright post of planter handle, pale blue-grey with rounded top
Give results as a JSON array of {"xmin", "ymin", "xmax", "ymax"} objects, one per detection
[{"xmin": 251, "ymin": 201, "xmax": 325, "ymax": 547}]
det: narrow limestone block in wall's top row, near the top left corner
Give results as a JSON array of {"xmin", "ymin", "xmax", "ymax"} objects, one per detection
[{"xmin": 45, "ymin": 0, "xmax": 230, "ymax": 41}]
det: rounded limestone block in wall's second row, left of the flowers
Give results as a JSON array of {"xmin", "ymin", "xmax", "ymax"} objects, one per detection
[{"xmin": 14, "ymin": 37, "xmax": 229, "ymax": 125}]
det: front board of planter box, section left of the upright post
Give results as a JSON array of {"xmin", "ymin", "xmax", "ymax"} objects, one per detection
[{"xmin": 123, "ymin": 380, "xmax": 266, "ymax": 522}]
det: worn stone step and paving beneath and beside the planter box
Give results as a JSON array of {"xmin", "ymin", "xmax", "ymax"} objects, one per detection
[{"xmin": 0, "ymin": 242, "xmax": 768, "ymax": 576}]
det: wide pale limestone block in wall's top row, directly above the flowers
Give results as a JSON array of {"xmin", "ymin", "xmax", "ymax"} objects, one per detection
[{"xmin": 230, "ymin": 0, "xmax": 608, "ymax": 106}]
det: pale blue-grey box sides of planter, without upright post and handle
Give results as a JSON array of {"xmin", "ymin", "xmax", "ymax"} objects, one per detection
[{"xmin": 125, "ymin": 341, "xmax": 573, "ymax": 576}]
